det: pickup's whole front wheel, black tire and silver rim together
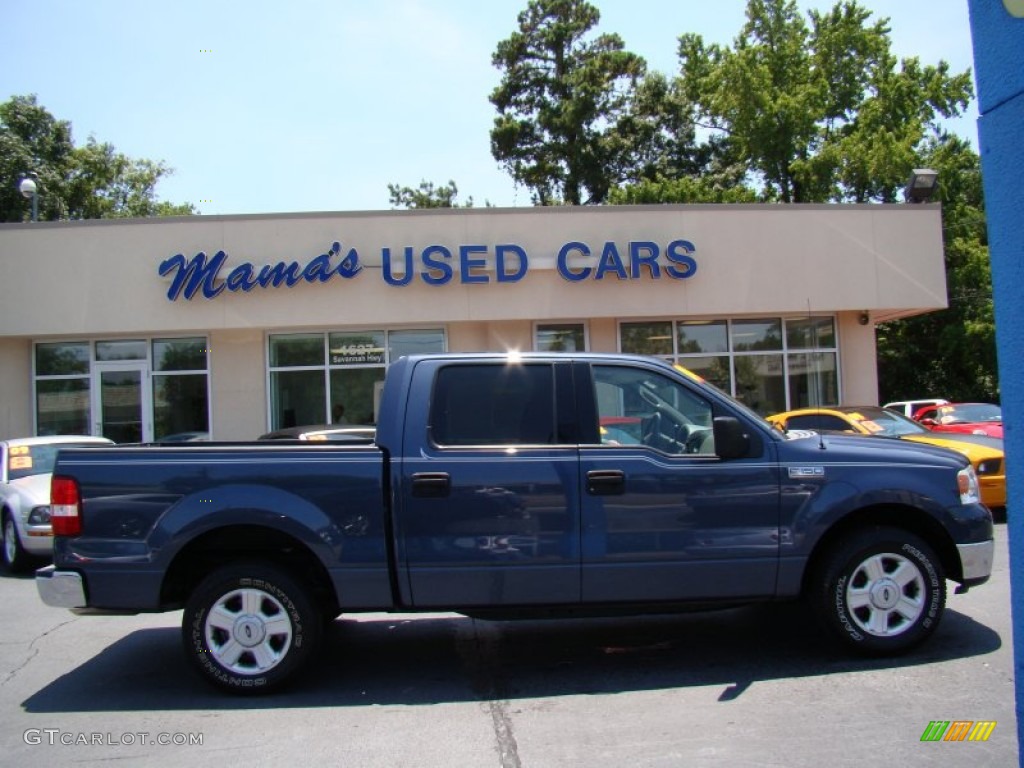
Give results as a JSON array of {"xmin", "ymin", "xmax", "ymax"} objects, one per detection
[{"xmin": 811, "ymin": 527, "xmax": 946, "ymax": 655}]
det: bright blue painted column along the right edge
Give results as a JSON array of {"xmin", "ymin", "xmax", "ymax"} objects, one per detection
[{"xmin": 968, "ymin": 0, "xmax": 1024, "ymax": 768}]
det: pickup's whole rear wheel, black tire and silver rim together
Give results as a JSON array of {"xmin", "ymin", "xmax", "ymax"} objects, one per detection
[{"xmin": 181, "ymin": 562, "xmax": 323, "ymax": 694}]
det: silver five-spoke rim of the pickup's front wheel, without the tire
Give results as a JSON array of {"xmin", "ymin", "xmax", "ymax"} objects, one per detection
[{"xmin": 846, "ymin": 553, "xmax": 927, "ymax": 637}]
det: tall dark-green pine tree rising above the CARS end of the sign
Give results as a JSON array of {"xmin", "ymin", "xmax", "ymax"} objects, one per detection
[{"xmin": 490, "ymin": 0, "xmax": 646, "ymax": 205}]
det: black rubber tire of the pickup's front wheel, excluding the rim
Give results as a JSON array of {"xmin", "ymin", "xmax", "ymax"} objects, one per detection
[{"xmin": 822, "ymin": 536, "xmax": 945, "ymax": 654}]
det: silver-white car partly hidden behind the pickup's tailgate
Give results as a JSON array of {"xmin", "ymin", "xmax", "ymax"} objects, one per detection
[{"xmin": 0, "ymin": 435, "xmax": 114, "ymax": 572}]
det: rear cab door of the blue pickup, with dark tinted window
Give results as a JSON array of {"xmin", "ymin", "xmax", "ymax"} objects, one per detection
[{"xmin": 393, "ymin": 360, "xmax": 580, "ymax": 607}]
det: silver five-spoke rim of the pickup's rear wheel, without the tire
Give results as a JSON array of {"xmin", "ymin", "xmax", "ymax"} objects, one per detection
[{"xmin": 204, "ymin": 589, "xmax": 294, "ymax": 675}]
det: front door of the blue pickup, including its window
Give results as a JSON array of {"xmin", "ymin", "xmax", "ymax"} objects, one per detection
[{"xmin": 577, "ymin": 362, "xmax": 779, "ymax": 603}]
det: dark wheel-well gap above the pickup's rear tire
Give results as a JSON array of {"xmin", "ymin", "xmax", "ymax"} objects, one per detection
[{"xmin": 160, "ymin": 524, "xmax": 340, "ymax": 614}]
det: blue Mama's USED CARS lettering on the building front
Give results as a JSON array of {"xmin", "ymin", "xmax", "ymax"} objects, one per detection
[{"xmin": 160, "ymin": 240, "xmax": 697, "ymax": 301}]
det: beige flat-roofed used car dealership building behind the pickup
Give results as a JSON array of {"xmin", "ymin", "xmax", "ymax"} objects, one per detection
[{"xmin": 0, "ymin": 204, "xmax": 946, "ymax": 441}]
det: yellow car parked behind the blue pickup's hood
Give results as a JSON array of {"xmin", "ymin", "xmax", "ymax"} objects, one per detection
[{"xmin": 768, "ymin": 406, "xmax": 1007, "ymax": 508}]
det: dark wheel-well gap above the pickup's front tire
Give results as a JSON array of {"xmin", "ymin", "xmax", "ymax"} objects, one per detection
[{"xmin": 801, "ymin": 504, "xmax": 963, "ymax": 595}]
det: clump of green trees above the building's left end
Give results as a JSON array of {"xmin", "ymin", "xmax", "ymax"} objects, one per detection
[{"xmin": 0, "ymin": 95, "xmax": 196, "ymax": 221}]
